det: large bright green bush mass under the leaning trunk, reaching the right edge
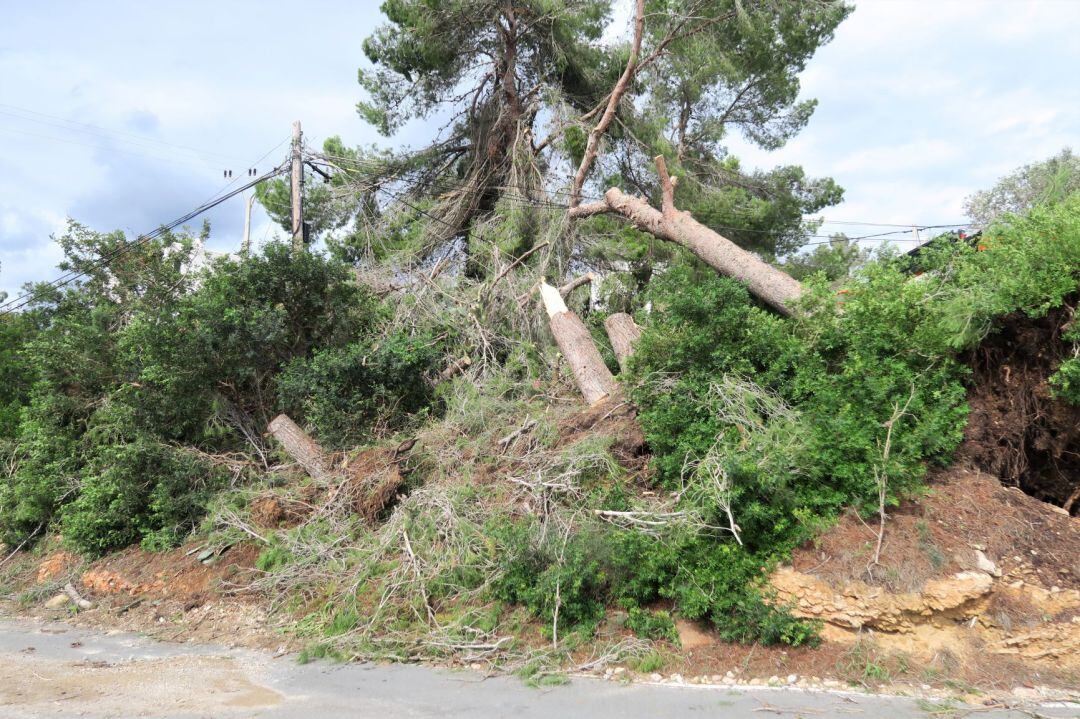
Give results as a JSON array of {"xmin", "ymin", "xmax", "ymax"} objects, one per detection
[{"xmin": 608, "ymin": 195, "xmax": 1080, "ymax": 643}]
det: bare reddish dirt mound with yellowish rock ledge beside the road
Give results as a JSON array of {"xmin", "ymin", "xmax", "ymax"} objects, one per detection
[{"xmin": 771, "ymin": 467, "xmax": 1080, "ymax": 681}]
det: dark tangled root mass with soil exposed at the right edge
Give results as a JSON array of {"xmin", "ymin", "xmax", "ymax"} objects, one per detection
[{"xmin": 958, "ymin": 296, "xmax": 1080, "ymax": 514}]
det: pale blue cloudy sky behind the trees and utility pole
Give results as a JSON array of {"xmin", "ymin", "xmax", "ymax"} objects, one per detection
[{"xmin": 0, "ymin": 0, "xmax": 1080, "ymax": 293}]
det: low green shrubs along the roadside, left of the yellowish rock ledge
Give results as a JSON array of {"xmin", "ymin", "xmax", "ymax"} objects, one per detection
[{"xmin": 490, "ymin": 509, "xmax": 816, "ymax": 645}]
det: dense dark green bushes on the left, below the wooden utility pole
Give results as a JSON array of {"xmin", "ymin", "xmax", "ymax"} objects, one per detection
[{"xmin": 0, "ymin": 225, "xmax": 437, "ymax": 553}]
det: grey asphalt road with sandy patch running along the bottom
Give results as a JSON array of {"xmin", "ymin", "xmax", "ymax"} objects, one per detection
[{"xmin": 0, "ymin": 618, "xmax": 1080, "ymax": 719}]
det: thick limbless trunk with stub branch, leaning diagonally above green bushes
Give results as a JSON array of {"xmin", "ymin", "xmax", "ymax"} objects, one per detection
[{"xmin": 569, "ymin": 155, "xmax": 802, "ymax": 315}]
